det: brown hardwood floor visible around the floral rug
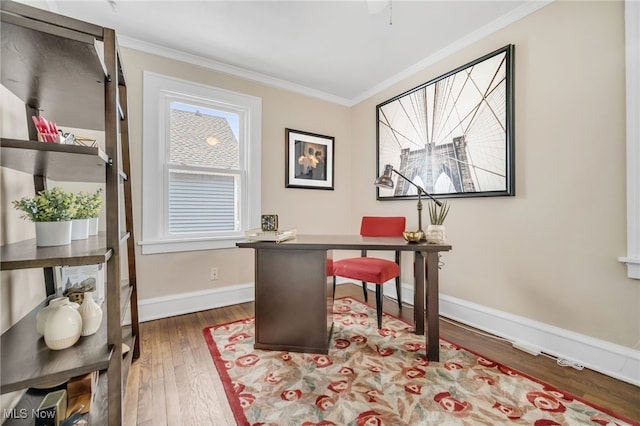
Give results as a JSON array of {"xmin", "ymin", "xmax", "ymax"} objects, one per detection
[{"xmin": 125, "ymin": 284, "xmax": 640, "ymax": 426}]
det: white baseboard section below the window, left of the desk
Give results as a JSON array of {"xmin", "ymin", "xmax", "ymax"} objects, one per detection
[{"xmin": 138, "ymin": 283, "xmax": 254, "ymax": 322}]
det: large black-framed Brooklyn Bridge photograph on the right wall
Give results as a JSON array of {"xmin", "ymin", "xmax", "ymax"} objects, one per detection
[{"xmin": 376, "ymin": 45, "xmax": 515, "ymax": 200}]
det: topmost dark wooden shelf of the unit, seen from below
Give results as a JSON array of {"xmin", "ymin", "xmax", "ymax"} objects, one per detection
[{"xmin": 0, "ymin": 8, "xmax": 106, "ymax": 130}]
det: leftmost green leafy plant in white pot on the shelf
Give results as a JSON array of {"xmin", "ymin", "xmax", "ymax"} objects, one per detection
[{"xmin": 13, "ymin": 187, "xmax": 76, "ymax": 247}]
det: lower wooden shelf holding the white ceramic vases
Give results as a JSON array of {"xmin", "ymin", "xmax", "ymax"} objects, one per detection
[{"xmin": 0, "ymin": 304, "xmax": 112, "ymax": 394}]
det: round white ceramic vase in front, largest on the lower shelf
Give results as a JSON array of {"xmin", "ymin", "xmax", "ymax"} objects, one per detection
[{"xmin": 43, "ymin": 297, "xmax": 82, "ymax": 350}]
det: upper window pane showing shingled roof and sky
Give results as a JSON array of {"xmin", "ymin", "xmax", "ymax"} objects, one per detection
[{"xmin": 169, "ymin": 102, "xmax": 240, "ymax": 169}]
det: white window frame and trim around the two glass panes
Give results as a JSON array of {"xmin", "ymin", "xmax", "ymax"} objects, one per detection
[{"xmin": 139, "ymin": 71, "xmax": 262, "ymax": 254}]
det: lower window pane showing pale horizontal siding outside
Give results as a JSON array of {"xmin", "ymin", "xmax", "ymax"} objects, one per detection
[{"xmin": 169, "ymin": 170, "xmax": 239, "ymax": 234}]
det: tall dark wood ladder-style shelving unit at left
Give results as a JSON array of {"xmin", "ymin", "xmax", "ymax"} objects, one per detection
[{"xmin": 0, "ymin": 0, "xmax": 140, "ymax": 425}]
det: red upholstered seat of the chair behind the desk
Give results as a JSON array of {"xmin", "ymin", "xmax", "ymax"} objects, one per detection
[{"xmin": 333, "ymin": 257, "xmax": 400, "ymax": 284}]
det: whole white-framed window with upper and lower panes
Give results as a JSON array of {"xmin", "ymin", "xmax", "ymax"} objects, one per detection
[{"xmin": 140, "ymin": 72, "xmax": 261, "ymax": 254}]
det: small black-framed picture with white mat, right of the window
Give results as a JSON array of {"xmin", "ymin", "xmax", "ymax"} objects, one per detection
[{"xmin": 285, "ymin": 129, "xmax": 335, "ymax": 190}]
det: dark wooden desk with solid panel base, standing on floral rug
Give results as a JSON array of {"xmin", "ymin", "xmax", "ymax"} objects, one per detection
[{"xmin": 236, "ymin": 235, "xmax": 451, "ymax": 362}]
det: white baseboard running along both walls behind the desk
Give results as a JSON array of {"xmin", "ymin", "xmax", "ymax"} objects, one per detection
[{"xmin": 138, "ymin": 278, "xmax": 640, "ymax": 386}]
